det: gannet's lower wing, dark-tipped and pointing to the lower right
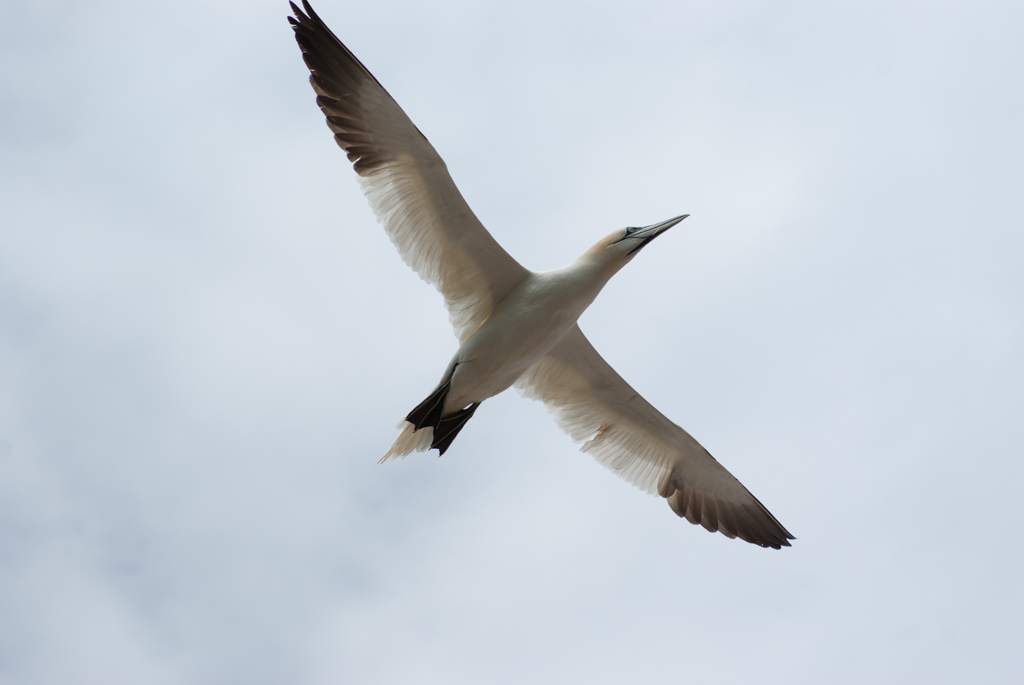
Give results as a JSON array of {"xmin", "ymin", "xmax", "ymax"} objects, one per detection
[{"xmin": 516, "ymin": 326, "xmax": 794, "ymax": 549}]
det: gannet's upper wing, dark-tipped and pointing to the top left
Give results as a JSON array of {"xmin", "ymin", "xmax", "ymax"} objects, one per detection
[{"xmin": 288, "ymin": 0, "xmax": 528, "ymax": 340}]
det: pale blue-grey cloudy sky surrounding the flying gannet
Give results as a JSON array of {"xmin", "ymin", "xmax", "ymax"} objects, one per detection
[{"xmin": 0, "ymin": 0, "xmax": 1024, "ymax": 685}]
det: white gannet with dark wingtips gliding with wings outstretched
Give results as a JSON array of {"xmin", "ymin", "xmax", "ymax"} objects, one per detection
[{"xmin": 288, "ymin": 0, "xmax": 796, "ymax": 549}]
